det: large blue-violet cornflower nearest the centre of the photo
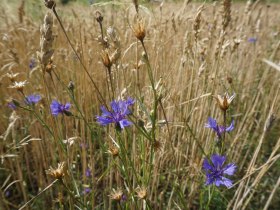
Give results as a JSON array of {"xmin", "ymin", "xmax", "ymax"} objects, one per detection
[{"xmin": 96, "ymin": 98, "xmax": 134, "ymax": 129}]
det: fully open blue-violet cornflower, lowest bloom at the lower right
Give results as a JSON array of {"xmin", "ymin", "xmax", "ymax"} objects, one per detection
[{"xmin": 203, "ymin": 154, "xmax": 237, "ymax": 188}]
